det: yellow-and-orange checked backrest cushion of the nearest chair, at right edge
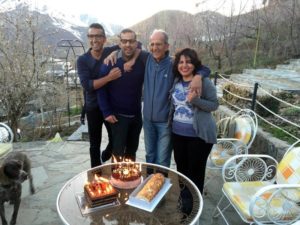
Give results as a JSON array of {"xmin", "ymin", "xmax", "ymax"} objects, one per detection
[{"xmin": 276, "ymin": 147, "xmax": 300, "ymax": 184}]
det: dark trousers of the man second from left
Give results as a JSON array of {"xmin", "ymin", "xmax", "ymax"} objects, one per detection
[{"xmin": 110, "ymin": 114, "xmax": 143, "ymax": 161}]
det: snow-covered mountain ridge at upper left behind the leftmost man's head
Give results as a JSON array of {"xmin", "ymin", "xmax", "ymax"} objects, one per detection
[{"xmin": 0, "ymin": 0, "xmax": 122, "ymax": 40}]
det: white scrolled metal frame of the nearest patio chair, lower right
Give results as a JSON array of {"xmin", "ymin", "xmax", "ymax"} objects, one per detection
[{"xmin": 213, "ymin": 140, "xmax": 300, "ymax": 225}]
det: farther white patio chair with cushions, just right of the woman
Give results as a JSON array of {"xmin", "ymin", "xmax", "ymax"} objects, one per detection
[{"xmin": 205, "ymin": 109, "xmax": 258, "ymax": 186}]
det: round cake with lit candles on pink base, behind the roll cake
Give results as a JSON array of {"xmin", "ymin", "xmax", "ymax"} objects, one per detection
[{"xmin": 110, "ymin": 162, "xmax": 142, "ymax": 189}]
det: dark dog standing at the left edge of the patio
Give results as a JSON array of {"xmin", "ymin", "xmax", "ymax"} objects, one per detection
[{"xmin": 0, "ymin": 152, "xmax": 35, "ymax": 225}]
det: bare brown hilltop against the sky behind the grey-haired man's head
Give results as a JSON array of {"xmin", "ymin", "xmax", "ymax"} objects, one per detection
[{"xmin": 131, "ymin": 10, "xmax": 227, "ymax": 51}]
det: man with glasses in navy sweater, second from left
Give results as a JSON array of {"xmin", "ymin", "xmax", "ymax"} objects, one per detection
[{"xmin": 97, "ymin": 29, "xmax": 147, "ymax": 161}]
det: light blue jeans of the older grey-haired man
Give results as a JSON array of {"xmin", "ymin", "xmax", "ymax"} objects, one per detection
[{"xmin": 144, "ymin": 118, "xmax": 172, "ymax": 167}]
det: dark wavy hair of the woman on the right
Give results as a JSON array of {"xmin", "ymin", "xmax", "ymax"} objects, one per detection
[{"xmin": 173, "ymin": 48, "xmax": 202, "ymax": 78}]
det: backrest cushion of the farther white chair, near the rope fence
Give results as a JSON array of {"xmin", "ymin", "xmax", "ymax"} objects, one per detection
[{"xmin": 234, "ymin": 117, "xmax": 252, "ymax": 145}]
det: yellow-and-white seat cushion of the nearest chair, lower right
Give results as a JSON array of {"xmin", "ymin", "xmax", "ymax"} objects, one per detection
[{"xmin": 223, "ymin": 181, "xmax": 300, "ymax": 221}]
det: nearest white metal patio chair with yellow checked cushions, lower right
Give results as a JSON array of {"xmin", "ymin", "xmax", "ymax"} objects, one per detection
[{"xmin": 213, "ymin": 141, "xmax": 300, "ymax": 225}]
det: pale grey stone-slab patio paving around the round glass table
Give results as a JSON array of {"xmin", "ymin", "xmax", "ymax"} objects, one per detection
[{"xmin": 5, "ymin": 126, "xmax": 244, "ymax": 225}]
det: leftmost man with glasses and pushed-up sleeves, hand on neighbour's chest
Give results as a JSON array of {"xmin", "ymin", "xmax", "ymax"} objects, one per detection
[{"xmin": 77, "ymin": 23, "xmax": 121, "ymax": 167}]
